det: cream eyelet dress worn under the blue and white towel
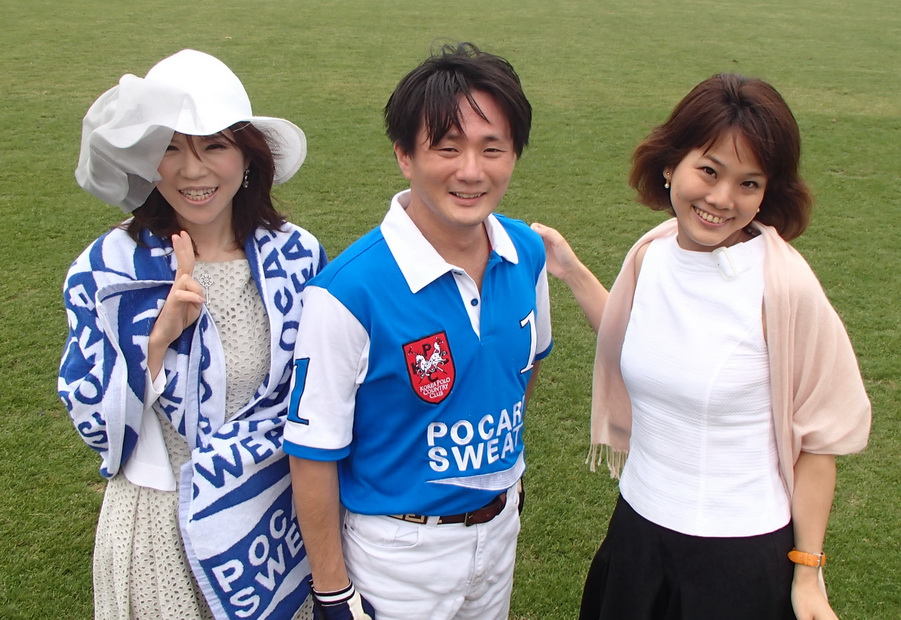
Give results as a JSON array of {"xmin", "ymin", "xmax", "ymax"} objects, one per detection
[{"xmin": 94, "ymin": 259, "xmax": 312, "ymax": 620}]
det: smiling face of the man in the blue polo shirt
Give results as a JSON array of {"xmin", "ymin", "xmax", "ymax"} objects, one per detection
[{"xmin": 395, "ymin": 91, "xmax": 516, "ymax": 242}]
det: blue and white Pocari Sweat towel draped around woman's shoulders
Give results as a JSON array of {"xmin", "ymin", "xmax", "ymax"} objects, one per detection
[{"xmin": 58, "ymin": 224, "xmax": 326, "ymax": 618}]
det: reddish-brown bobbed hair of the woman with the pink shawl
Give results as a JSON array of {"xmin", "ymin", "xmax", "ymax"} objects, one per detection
[{"xmin": 629, "ymin": 73, "xmax": 813, "ymax": 240}]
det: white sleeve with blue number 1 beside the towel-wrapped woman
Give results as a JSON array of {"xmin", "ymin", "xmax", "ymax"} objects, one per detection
[{"xmin": 284, "ymin": 286, "xmax": 369, "ymax": 461}]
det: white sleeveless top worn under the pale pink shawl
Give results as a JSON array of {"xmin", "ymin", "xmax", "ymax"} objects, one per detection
[{"xmin": 620, "ymin": 237, "xmax": 791, "ymax": 537}]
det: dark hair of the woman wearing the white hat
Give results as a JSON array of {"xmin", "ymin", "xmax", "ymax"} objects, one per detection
[{"xmin": 124, "ymin": 122, "xmax": 285, "ymax": 247}]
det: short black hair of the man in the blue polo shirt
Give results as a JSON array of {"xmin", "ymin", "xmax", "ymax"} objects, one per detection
[{"xmin": 385, "ymin": 43, "xmax": 532, "ymax": 157}]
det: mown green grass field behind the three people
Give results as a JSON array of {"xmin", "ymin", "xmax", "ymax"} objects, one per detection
[{"xmin": 0, "ymin": 0, "xmax": 901, "ymax": 620}]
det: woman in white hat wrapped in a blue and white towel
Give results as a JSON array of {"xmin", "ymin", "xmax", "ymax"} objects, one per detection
[{"xmin": 58, "ymin": 50, "xmax": 326, "ymax": 618}]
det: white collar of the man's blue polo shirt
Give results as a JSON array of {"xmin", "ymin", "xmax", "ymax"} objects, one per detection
[{"xmin": 381, "ymin": 189, "xmax": 519, "ymax": 293}]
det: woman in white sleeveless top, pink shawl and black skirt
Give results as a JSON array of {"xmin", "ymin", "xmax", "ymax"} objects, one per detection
[{"xmin": 533, "ymin": 74, "xmax": 870, "ymax": 620}]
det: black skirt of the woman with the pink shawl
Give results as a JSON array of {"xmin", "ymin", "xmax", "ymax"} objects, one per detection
[{"xmin": 579, "ymin": 496, "xmax": 795, "ymax": 620}]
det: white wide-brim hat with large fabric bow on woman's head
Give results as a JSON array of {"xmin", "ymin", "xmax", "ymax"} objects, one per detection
[{"xmin": 75, "ymin": 50, "xmax": 307, "ymax": 213}]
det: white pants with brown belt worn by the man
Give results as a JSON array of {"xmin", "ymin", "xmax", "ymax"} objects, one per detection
[{"xmin": 344, "ymin": 487, "xmax": 519, "ymax": 620}]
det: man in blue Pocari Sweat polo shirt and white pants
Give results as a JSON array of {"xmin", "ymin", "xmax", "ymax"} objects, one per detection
[{"xmin": 285, "ymin": 44, "xmax": 551, "ymax": 620}]
